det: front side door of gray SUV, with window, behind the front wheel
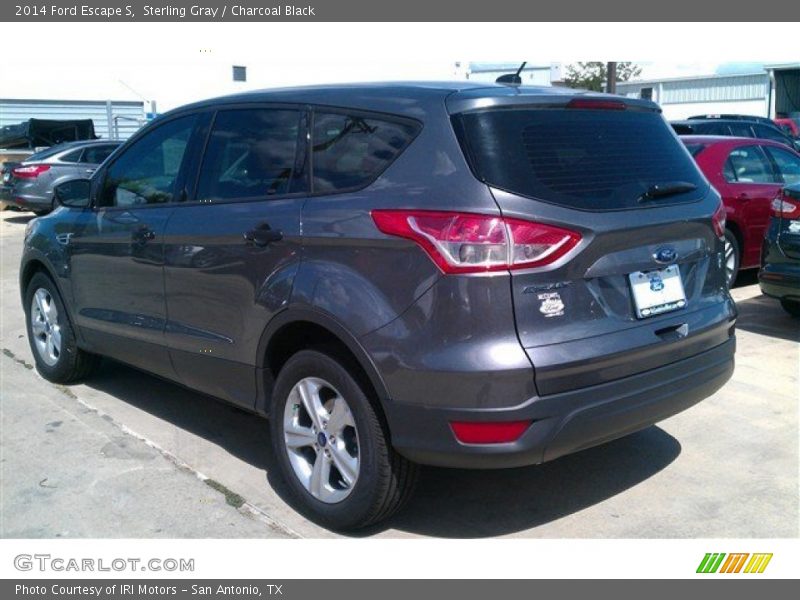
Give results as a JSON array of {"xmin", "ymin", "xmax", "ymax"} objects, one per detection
[{"xmin": 69, "ymin": 115, "xmax": 202, "ymax": 377}]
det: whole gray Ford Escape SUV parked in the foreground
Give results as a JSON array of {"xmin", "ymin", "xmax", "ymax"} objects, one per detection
[{"xmin": 20, "ymin": 83, "xmax": 736, "ymax": 529}]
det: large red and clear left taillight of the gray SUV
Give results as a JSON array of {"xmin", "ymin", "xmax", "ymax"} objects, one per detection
[{"xmin": 372, "ymin": 210, "xmax": 581, "ymax": 273}]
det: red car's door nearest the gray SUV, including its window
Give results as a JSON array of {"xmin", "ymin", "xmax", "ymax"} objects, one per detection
[{"xmin": 719, "ymin": 144, "xmax": 780, "ymax": 268}]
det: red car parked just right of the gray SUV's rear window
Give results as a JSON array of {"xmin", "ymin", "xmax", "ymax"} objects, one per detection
[{"xmin": 681, "ymin": 135, "xmax": 800, "ymax": 285}]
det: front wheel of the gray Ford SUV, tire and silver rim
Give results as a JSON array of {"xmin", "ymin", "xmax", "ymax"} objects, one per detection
[{"xmin": 25, "ymin": 272, "xmax": 100, "ymax": 383}]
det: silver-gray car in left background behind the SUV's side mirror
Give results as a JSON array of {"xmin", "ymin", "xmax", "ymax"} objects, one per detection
[{"xmin": 2, "ymin": 140, "xmax": 122, "ymax": 215}]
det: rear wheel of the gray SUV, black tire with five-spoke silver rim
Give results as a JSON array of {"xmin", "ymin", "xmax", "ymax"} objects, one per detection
[{"xmin": 270, "ymin": 350, "xmax": 419, "ymax": 530}]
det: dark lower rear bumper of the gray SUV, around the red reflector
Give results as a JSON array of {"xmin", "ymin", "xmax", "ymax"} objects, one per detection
[{"xmin": 386, "ymin": 337, "xmax": 736, "ymax": 469}]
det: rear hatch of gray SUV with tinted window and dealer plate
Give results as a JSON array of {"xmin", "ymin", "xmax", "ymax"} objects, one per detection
[{"xmin": 450, "ymin": 92, "xmax": 734, "ymax": 395}]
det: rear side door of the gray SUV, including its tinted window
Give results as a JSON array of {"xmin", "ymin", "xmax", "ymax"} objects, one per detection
[{"xmin": 165, "ymin": 105, "xmax": 308, "ymax": 407}]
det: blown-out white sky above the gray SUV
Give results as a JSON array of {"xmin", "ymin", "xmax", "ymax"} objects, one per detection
[{"xmin": 0, "ymin": 23, "xmax": 794, "ymax": 112}]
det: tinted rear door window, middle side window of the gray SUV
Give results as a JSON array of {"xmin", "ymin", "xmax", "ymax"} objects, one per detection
[{"xmin": 197, "ymin": 109, "xmax": 305, "ymax": 201}]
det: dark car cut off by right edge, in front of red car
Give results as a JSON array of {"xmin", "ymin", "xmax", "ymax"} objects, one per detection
[{"xmin": 758, "ymin": 184, "xmax": 800, "ymax": 317}]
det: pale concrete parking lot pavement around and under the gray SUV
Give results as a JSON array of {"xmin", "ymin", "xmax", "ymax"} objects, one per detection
[{"xmin": 0, "ymin": 211, "xmax": 800, "ymax": 538}]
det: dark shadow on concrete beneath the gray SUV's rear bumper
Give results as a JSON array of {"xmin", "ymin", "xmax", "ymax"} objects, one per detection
[{"xmin": 376, "ymin": 426, "xmax": 681, "ymax": 538}]
